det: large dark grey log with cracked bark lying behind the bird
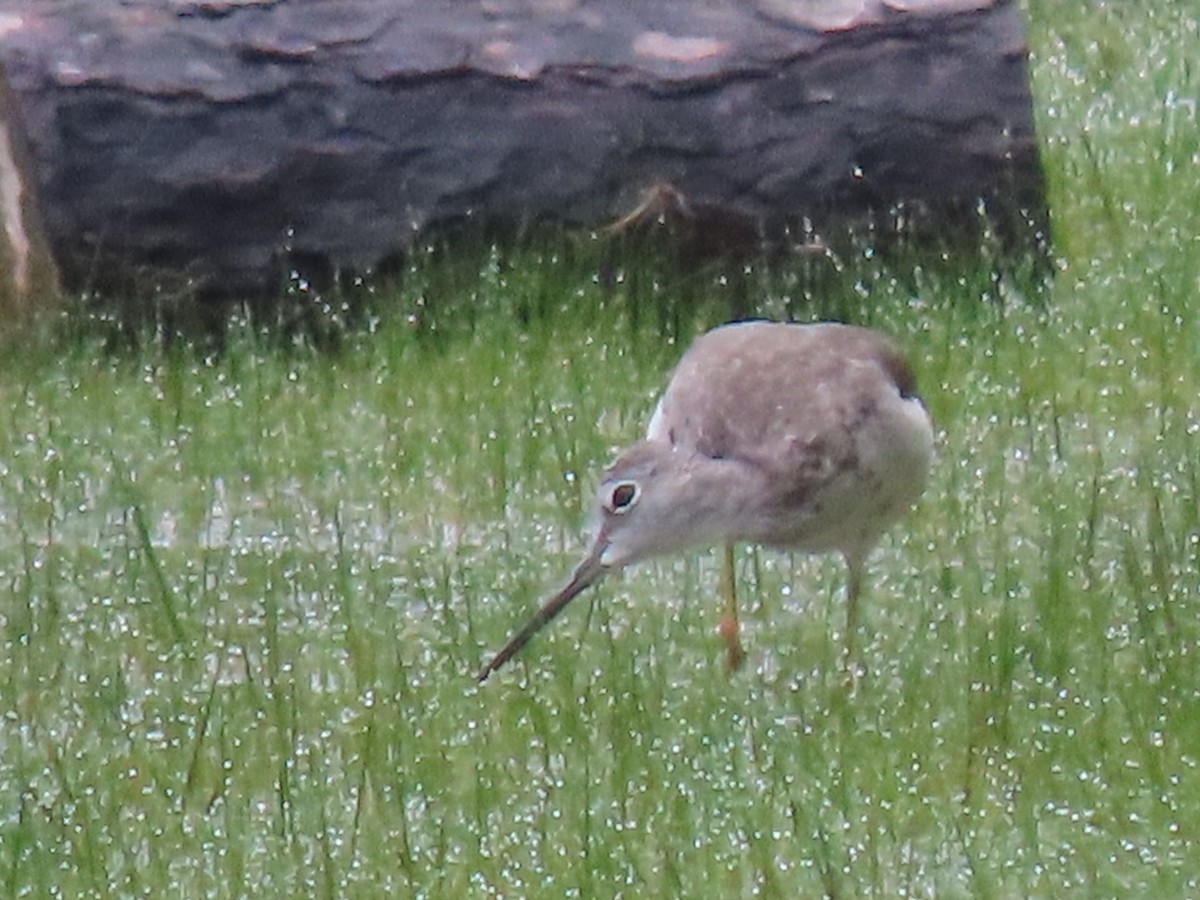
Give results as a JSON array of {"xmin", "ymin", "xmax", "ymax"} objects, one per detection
[{"xmin": 0, "ymin": 0, "xmax": 1045, "ymax": 296}]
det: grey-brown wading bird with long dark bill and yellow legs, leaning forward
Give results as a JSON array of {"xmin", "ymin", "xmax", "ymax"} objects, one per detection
[{"xmin": 478, "ymin": 320, "xmax": 935, "ymax": 683}]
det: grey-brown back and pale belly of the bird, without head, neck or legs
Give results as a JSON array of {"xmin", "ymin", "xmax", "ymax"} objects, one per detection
[{"xmin": 647, "ymin": 322, "xmax": 932, "ymax": 550}]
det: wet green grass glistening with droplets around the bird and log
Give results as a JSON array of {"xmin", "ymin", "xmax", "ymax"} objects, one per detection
[{"xmin": 0, "ymin": 0, "xmax": 1200, "ymax": 900}]
